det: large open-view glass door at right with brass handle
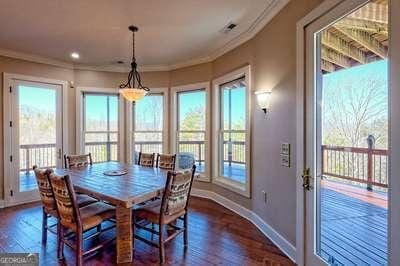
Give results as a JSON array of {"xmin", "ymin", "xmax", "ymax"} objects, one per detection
[{"xmin": 302, "ymin": 0, "xmax": 390, "ymax": 265}]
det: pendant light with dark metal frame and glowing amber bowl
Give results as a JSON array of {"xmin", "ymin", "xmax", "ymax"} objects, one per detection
[{"xmin": 119, "ymin": 26, "xmax": 150, "ymax": 102}]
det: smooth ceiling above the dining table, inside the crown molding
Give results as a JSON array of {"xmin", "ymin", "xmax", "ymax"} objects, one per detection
[{"xmin": 0, "ymin": 0, "xmax": 288, "ymax": 68}]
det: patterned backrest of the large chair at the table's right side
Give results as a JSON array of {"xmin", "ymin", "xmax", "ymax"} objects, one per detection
[{"xmin": 160, "ymin": 165, "xmax": 196, "ymax": 216}]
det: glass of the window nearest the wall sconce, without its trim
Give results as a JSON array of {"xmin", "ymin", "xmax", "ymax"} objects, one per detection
[{"xmin": 219, "ymin": 79, "xmax": 247, "ymax": 183}]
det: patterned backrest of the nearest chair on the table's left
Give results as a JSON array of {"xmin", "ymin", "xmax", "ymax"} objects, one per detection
[{"xmin": 48, "ymin": 173, "xmax": 81, "ymax": 228}]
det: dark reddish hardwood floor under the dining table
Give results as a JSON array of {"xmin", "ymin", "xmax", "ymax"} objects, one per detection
[{"xmin": 0, "ymin": 197, "xmax": 294, "ymax": 265}]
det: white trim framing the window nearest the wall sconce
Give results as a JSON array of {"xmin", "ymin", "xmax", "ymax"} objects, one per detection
[{"xmin": 212, "ymin": 65, "xmax": 252, "ymax": 198}]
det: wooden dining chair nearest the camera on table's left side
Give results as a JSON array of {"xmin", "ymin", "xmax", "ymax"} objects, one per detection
[{"xmin": 48, "ymin": 173, "xmax": 115, "ymax": 266}]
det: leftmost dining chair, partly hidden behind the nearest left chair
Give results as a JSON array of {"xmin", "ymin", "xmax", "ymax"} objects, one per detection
[{"xmin": 33, "ymin": 165, "xmax": 97, "ymax": 245}]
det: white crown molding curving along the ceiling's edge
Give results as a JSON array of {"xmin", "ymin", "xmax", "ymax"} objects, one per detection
[{"xmin": 0, "ymin": 0, "xmax": 290, "ymax": 73}]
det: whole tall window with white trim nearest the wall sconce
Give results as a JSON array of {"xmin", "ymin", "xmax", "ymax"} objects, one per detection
[{"xmin": 213, "ymin": 67, "xmax": 250, "ymax": 196}]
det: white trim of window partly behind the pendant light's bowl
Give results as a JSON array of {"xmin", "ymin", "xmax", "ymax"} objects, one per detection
[{"xmin": 125, "ymin": 88, "xmax": 170, "ymax": 163}]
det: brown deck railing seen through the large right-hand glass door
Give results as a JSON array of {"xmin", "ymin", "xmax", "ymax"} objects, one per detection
[{"xmin": 321, "ymin": 145, "xmax": 389, "ymax": 190}]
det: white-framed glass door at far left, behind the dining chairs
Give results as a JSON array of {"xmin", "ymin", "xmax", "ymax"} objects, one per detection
[{"xmin": 5, "ymin": 80, "xmax": 62, "ymax": 204}]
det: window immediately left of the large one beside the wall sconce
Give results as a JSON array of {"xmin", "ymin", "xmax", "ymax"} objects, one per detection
[{"xmin": 171, "ymin": 82, "xmax": 210, "ymax": 181}]
